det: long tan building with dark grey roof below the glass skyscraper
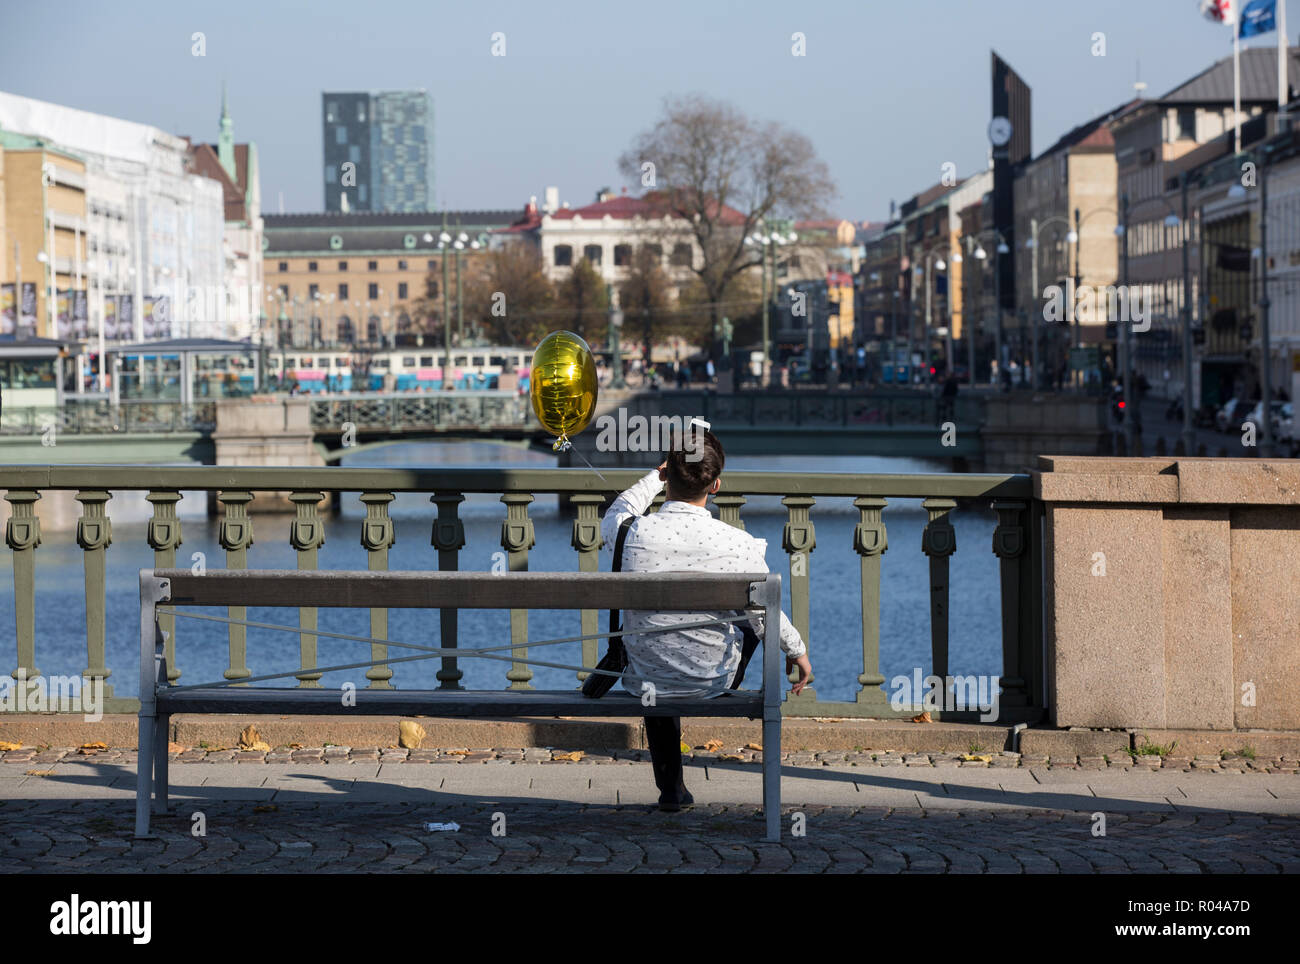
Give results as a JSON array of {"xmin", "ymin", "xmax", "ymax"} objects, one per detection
[{"xmin": 263, "ymin": 209, "xmax": 519, "ymax": 346}]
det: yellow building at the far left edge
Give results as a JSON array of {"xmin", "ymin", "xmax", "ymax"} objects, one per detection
[{"xmin": 0, "ymin": 131, "xmax": 87, "ymax": 338}]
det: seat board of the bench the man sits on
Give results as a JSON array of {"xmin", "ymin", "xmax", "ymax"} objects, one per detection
[{"xmin": 157, "ymin": 686, "xmax": 763, "ymax": 720}]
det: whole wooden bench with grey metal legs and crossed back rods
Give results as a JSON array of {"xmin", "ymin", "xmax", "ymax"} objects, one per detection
[{"xmin": 135, "ymin": 569, "xmax": 785, "ymax": 842}]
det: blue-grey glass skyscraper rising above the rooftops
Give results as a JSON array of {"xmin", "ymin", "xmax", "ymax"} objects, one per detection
[{"xmin": 321, "ymin": 90, "xmax": 433, "ymax": 212}]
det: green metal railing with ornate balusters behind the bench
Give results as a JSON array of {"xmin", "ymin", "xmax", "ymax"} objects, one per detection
[{"xmin": 0, "ymin": 465, "xmax": 1044, "ymax": 721}]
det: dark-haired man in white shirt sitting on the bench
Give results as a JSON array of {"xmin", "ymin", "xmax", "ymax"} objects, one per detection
[{"xmin": 601, "ymin": 422, "xmax": 813, "ymax": 812}]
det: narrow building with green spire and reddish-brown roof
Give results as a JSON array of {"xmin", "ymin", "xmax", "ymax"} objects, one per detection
[{"xmin": 191, "ymin": 90, "xmax": 263, "ymax": 339}]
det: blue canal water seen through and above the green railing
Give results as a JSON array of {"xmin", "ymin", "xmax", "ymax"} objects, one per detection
[{"xmin": 0, "ymin": 442, "xmax": 1001, "ymax": 700}]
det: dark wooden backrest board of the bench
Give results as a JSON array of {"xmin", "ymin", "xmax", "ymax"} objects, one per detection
[{"xmin": 154, "ymin": 569, "xmax": 767, "ymax": 612}]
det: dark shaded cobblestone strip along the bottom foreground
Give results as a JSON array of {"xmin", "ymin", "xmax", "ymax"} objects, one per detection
[{"xmin": 0, "ymin": 800, "xmax": 1300, "ymax": 873}]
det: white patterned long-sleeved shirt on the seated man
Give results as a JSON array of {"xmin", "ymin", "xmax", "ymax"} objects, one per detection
[{"xmin": 601, "ymin": 469, "xmax": 807, "ymax": 696}]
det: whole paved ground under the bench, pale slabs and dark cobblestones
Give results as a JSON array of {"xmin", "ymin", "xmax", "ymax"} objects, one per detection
[{"xmin": 0, "ymin": 747, "xmax": 1300, "ymax": 873}]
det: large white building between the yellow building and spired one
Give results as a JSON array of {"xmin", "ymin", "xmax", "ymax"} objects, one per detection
[{"xmin": 0, "ymin": 91, "xmax": 227, "ymax": 344}]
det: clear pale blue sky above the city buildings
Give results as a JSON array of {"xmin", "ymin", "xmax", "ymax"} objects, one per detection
[{"xmin": 0, "ymin": 0, "xmax": 1300, "ymax": 220}]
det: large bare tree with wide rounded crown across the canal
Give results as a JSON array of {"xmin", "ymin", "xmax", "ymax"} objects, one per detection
[{"xmin": 619, "ymin": 95, "xmax": 836, "ymax": 356}]
